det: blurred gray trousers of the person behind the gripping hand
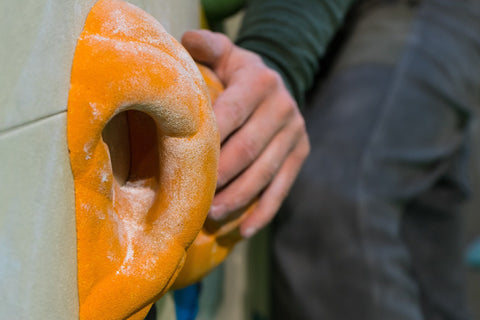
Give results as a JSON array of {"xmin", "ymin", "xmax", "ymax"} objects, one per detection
[{"xmin": 271, "ymin": 0, "xmax": 480, "ymax": 320}]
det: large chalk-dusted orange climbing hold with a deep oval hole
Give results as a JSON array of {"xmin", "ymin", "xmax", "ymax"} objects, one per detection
[{"xmin": 67, "ymin": 0, "xmax": 219, "ymax": 319}]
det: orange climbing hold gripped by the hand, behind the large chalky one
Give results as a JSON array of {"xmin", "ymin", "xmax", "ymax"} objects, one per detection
[{"xmin": 172, "ymin": 65, "xmax": 257, "ymax": 289}]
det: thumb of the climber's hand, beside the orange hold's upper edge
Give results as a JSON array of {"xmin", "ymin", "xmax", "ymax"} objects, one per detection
[{"xmin": 181, "ymin": 30, "xmax": 233, "ymax": 71}]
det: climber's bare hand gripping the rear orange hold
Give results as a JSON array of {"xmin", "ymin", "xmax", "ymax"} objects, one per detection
[{"xmin": 182, "ymin": 30, "xmax": 310, "ymax": 237}]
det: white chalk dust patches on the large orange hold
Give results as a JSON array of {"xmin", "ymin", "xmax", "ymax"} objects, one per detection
[{"xmin": 85, "ymin": 0, "xmax": 218, "ymax": 277}]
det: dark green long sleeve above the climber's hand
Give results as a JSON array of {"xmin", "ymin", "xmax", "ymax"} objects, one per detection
[{"xmin": 236, "ymin": 0, "xmax": 354, "ymax": 104}]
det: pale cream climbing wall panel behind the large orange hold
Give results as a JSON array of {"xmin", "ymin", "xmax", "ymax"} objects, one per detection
[{"xmin": 0, "ymin": 0, "xmax": 200, "ymax": 319}]
